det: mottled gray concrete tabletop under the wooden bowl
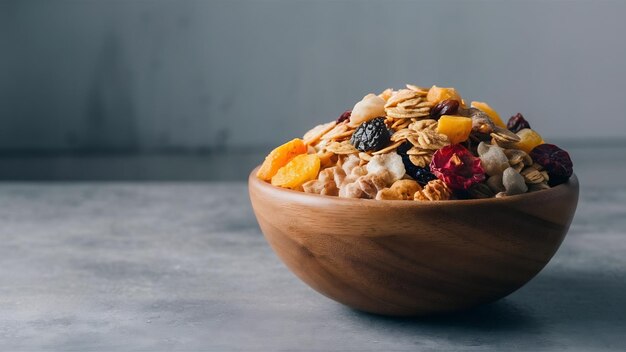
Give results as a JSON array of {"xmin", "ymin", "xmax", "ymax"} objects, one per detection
[{"xmin": 0, "ymin": 173, "xmax": 626, "ymax": 351}]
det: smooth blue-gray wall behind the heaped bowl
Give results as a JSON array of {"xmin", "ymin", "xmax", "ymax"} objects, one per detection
[{"xmin": 0, "ymin": 0, "xmax": 626, "ymax": 151}]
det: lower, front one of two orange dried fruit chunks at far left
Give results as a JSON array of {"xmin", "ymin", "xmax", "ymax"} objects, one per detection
[{"xmin": 272, "ymin": 154, "xmax": 320, "ymax": 189}]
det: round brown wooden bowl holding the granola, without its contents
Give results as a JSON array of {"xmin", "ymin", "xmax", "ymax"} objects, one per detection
[{"xmin": 248, "ymin": 169, "xmax": 578, "ymax": 316}]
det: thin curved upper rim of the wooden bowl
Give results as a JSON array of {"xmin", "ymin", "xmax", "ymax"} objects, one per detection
[{"xmin": 248, "ymin": 165, "xmax": 579, "ymax": 208}]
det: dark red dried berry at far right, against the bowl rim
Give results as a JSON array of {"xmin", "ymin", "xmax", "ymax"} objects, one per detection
[{"xmin": 530, "ymin": 144, "xmax": 574, "ymax": 187}]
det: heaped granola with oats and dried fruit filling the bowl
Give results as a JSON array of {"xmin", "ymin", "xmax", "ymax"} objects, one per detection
[{"xmin": 257, "ymin": 84, "xmax": 572, "ymax": 201}]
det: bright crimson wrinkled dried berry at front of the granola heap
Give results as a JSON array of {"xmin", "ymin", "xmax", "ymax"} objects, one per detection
[{"xmin": 430, "ymin": 144, "xmax": 485, "ymax": 191}]
